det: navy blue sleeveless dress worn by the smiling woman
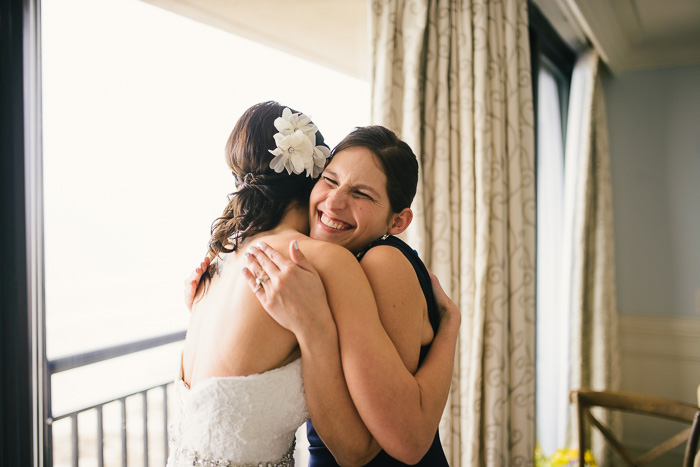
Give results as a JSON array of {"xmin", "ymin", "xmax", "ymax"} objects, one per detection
[{"xmin": 306, "ymin": 235, "xmax": 449, "ymax": 467}]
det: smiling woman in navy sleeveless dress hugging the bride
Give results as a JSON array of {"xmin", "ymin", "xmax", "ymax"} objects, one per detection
[{"xmin": 244, "ymin": 127, "xmax": 459, "ymax": 467}]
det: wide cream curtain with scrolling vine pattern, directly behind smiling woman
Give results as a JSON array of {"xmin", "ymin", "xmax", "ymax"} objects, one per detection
[{"xmin": 370, "ymin": 0, "xmax": 535, "ymax": 466}]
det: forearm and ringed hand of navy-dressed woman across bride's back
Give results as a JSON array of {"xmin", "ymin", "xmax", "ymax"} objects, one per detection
[{"xmin": 244, "ymin": 239, "xmax": 381, "ymax": 466}]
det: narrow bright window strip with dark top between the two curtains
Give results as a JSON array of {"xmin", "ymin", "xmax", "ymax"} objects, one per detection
[{"xmin": 529, "ymin": 3, "xmax": 575, "ymax": 456}]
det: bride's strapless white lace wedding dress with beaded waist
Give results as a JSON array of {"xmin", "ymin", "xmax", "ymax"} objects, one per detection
[{"xmin": 167, "ymin": 359, "xmax": 309, "ymax": 467}]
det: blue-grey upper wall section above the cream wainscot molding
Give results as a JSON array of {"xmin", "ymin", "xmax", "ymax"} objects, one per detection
[{"xmin": 604, "ymin": 66, "xmax": 700, "ymax": 318}]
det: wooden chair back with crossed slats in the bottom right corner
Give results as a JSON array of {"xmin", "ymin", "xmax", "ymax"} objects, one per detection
[{"xmin": 570, "ymin": 389, "xmax": 700, "ymax": 467}]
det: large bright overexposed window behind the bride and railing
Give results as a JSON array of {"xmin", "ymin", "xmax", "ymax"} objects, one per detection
[{"xmin": 41, "ymin": 0, "xmax": 370, "ymax": 465}]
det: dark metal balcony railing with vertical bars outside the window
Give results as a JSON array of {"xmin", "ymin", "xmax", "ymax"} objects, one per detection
[{"xmin": 44, "ymin": 331, "xmax": 185, "ymax": 467}]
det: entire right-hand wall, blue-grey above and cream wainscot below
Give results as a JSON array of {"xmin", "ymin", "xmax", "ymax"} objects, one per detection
[{"xmin": 604, "ymin": 66, "xmax": 700, "ymax": 465}]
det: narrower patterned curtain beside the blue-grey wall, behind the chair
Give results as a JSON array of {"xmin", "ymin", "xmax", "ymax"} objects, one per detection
[{"xmin": 561, "ymin": 51, "xmax": 621, "ymax": 465}]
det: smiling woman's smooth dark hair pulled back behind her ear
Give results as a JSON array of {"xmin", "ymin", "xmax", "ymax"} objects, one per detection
[{"xmin": 331, "ymin": 125, "xmax": 418, "ymax": 213}]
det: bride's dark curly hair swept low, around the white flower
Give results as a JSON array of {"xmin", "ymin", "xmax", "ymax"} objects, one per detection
[{"xmin": 208, "ymin": 101, "xmax": 327, "ymax": 259}]
